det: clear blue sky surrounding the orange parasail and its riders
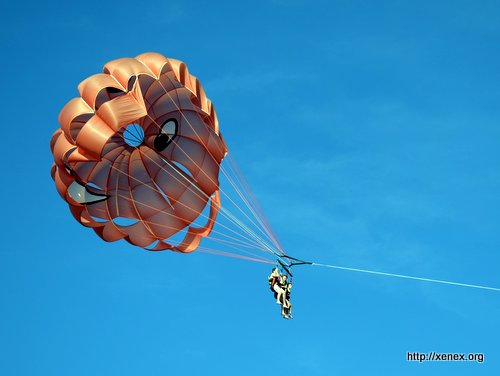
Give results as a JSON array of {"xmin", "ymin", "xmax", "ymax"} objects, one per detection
[{"xmin": 0, "ymin": 0, "xmax": 500, "ymax": 376}]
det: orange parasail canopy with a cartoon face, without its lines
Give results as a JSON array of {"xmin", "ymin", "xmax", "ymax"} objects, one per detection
[{"xmin": 50, "ymin": 53, "xmax": 227, "ymax": 252}]
